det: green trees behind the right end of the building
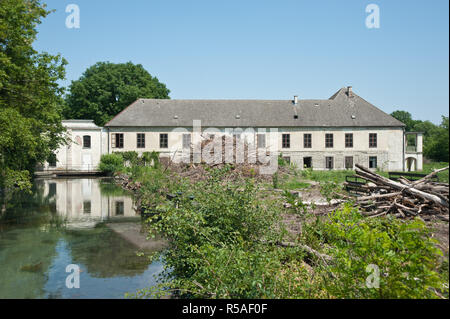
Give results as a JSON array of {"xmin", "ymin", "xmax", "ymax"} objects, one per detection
[{"xmin": 391, "ymin": 111, "xmax": 449, "ymax": 162}]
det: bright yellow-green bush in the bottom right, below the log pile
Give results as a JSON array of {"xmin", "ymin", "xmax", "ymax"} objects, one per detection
[{"xmin": 316, "ymin": 205, "xmax": 448, "ymax": 298}]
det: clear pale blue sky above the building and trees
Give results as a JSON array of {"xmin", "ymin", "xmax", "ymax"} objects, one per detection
[{"xmin": 35, "ymin": 0, "xmax": 449, "ymax": 123}]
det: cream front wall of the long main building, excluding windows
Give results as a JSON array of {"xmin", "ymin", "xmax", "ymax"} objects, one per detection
[{"xmin": 108, "ymin": 127, "xmax": 403, "ymax": 171}]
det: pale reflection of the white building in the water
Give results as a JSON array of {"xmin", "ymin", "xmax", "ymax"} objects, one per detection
[{"xmin": 44, "ymin": 178, "xmax": 137, "ymax": 228}]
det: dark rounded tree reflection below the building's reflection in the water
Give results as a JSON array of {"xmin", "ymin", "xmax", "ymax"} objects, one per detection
[{"xmin": 65, "ymin": 225, "xmax": 150, "ymax": 278}]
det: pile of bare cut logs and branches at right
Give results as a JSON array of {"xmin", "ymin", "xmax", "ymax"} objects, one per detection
[{"xmin": 356, "ymin": 165, "xmax": 449, "ymax": 221}]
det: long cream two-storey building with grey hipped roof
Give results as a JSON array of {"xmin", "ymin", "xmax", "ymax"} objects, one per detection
[{"xmin": 44, "ymin": 86, "xmax": 423, "ymax": 171}]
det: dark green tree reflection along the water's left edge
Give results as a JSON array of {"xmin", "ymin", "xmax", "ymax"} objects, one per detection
[{"xmin": 0, "ymin": 181, "xmax": 61, "ymax": 298}]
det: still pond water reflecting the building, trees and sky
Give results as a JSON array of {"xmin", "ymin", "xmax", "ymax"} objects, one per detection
[{"xmin": 0, "ymin": 179, "xmax": 164, "ymax": 298}]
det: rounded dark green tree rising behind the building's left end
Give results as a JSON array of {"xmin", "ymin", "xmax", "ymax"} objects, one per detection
[{"xmin": 64, "ymin": 62, "xmax": 170, "ymax": 126}]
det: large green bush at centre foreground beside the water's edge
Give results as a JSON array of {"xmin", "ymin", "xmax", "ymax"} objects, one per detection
[{"xmin": 136, "ymin": 168, "xmax": 280, "ymax": 298}]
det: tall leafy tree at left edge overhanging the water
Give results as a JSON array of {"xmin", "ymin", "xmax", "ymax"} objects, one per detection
[{"xmin": 0, "ymin": 0, "xmax": 67, "ymax": 192}]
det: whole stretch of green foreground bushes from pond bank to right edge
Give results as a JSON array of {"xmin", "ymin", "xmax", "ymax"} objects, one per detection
[{"xmin": 112, "ymin": 165, "xmax": 448, "ymax": 298}]
